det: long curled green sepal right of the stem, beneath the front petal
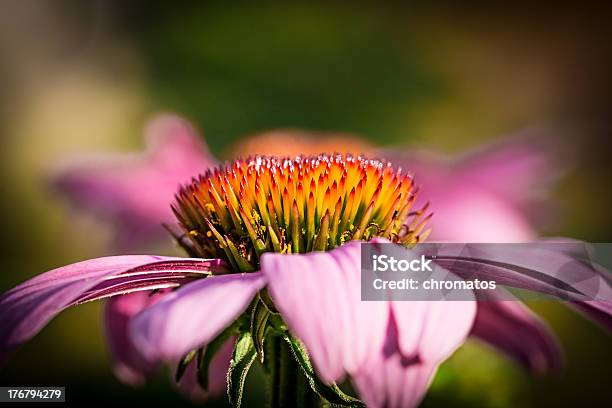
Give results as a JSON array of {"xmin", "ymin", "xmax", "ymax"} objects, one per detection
[{"xmin": 283, "ymin": 334, "xmax": 365, "ymax": 407}]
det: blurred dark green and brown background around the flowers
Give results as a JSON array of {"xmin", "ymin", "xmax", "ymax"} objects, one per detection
[{"xmin": 0, "ymin": 0, "xmax": 612, "ymax": 407}]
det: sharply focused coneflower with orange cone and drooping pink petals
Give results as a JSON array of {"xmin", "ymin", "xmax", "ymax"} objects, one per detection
[{"xmin": 0, "ymin": 116, "xmax": 612, "ymax": 407}]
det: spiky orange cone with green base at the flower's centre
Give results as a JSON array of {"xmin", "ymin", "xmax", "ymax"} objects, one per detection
[{"xmin": 172, "ymin": 154, "xmax": 431, "ymax": 272}]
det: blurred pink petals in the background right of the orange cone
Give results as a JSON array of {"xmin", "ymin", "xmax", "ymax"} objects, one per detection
[{"xmin": 379, "ymin": 132, "xmax": 558, "ymax": 242}]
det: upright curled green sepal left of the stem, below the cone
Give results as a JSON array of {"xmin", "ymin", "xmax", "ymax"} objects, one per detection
[{"xmin": 227, "ymin": 331, "xmax": 257, "ymax": 408}]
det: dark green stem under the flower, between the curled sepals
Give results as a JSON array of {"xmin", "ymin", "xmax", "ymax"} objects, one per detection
[{"xmin": 265, "ymin": 336, "xmax": 322, "ymax": 408}]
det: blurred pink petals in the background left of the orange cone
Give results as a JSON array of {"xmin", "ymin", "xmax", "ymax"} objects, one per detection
[{"xmin": 53, "ymin": 114, "xmax": 216, "ymax": 246}]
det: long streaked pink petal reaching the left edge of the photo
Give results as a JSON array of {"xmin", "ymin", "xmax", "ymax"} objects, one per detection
[{"xmin": 0, "ymin": 255, "xmax": 225, "ymax": 360}]
